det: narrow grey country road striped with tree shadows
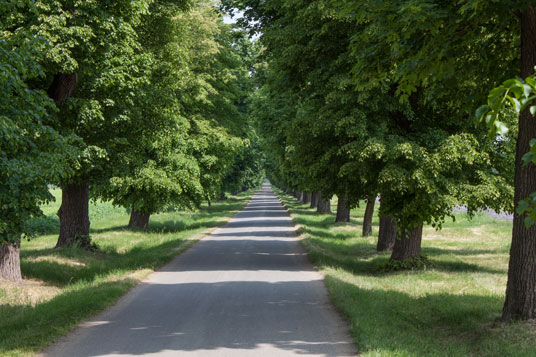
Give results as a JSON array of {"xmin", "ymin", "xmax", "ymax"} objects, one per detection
[{"xmin": 43, "ymin": 184, "xmax": 356, "ymax": 357}]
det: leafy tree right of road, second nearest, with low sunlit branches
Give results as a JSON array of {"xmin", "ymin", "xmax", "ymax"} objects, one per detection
[{"xmin": 332, "ymin": 0, "xmax": 513, "ymax": 260}]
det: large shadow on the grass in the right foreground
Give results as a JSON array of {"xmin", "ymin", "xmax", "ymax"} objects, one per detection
[{"xmin": 326, "ymin": 276, "xmax": 529, "ymax": 356}]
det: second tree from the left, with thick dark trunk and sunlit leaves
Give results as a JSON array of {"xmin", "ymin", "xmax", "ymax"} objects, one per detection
[{"xmin": 26, "ymin": 0, "xmax": 155, "ymax": 247}]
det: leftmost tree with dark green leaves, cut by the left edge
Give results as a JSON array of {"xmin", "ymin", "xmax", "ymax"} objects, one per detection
[{"xmin": 0, "ymin": 2, "xmax": 76, "ymax": 281}]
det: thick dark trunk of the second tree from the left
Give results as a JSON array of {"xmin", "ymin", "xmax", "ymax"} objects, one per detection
[{"xmin": 56, "ymin": 183, "xmax": 90, "ymax": 248}]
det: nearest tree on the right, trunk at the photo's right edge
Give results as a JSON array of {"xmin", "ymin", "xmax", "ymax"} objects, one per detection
[{"xmin": 338, "ymin": 0, "xmax": 536, "ymax": 320}]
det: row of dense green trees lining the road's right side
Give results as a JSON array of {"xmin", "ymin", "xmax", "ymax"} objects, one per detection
[{"xmin": 224, "ymin": 0, "xmax": 536, "ymax": 320}]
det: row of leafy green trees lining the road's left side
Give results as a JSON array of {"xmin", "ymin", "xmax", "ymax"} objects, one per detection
[{"xmin": 0, "ymin": 0, "xmax": 264, "ymax": 281}]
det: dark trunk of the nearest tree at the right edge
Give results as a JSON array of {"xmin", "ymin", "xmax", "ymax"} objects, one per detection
[{"xmin": 502, "ymin": 5, "xmax": 536, "ymax": 321}]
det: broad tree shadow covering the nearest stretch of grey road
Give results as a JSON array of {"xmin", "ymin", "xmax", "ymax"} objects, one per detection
[{"xmin": 40, "ymin": 280, "xmax": 355, "ymax": 356}]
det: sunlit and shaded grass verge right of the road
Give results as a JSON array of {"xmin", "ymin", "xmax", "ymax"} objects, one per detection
[{"xmin": 277, "ymin": 191, "xmax": 536, "ymax": 356}]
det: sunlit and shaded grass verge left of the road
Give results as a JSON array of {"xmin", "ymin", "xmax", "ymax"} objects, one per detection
[{"xmin": 0, "ymin": 190, "xmax": 252, "ymax": 356}]
